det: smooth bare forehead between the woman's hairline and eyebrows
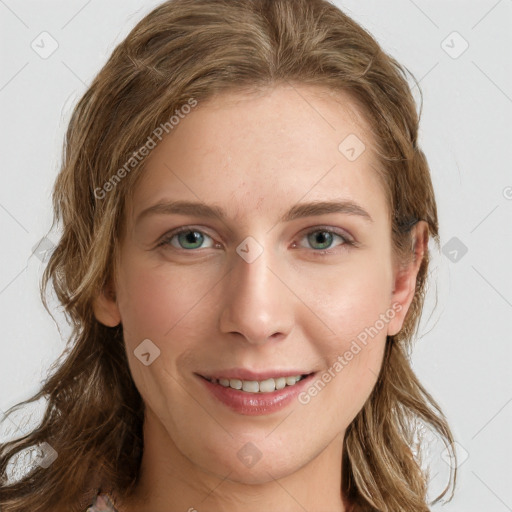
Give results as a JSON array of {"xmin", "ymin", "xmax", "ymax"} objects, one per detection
[{"xmin": 126, "ymin": 85, "xmax": 383, "ymax": 224}]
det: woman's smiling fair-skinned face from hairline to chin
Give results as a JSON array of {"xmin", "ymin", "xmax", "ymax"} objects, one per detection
[{"xmin": 95, "ymin": 86, "xmax": 417, "ymax": 483}]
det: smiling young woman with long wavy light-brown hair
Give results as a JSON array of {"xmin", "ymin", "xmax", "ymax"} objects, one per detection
[{"xmin": 0, "ymin": 0, "xmax": 455, "ymax": 512}]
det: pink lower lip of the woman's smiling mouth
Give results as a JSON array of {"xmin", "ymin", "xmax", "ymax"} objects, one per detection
[{"xmin": 199, "ymin": 373, "xmax": 315, "ymax": 416}]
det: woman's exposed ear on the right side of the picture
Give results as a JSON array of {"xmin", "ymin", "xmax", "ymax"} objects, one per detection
[{"xmin": 388, "ymin": 221, "xmax": 429, "ymax": 336}]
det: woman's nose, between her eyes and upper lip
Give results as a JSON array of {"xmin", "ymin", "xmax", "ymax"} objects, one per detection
[{"xmin": 220, "ymin": 238, "xmax": 298, "ymax": 345}]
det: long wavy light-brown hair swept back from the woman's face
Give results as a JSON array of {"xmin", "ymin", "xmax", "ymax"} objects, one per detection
[{"xmin": 0, "ymin": 0, "xmax": 456, "ymax": 512}]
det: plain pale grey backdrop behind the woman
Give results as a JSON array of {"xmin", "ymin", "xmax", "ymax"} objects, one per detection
[{"xmin": 0, "ymin": 0, "xmax": 512, "ymax": 512}]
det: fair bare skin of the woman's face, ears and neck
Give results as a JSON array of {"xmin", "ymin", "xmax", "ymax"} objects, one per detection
[{"xmin": 94, "ymin": 85, "xmax": 428, "ymax": 512}]
